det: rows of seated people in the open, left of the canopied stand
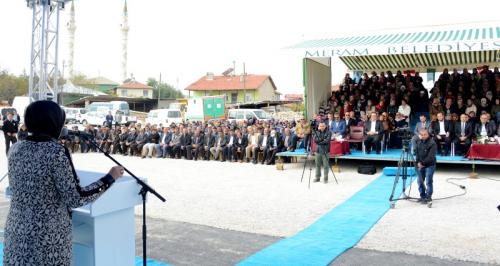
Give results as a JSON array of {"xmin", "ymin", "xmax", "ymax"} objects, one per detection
[{"xmin": 59, "ymin": 119, "xmax": 311, "ymax": 164}]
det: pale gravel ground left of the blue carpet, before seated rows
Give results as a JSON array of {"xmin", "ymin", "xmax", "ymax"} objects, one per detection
[{"xmin": 67, "ymin": 154, "xmax": 375, "ymax": 236}]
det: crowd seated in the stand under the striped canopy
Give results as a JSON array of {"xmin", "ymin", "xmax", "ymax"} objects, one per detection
[{"xmin": 317, "ymin": 66, "xmax": 500, "ymax": 155}]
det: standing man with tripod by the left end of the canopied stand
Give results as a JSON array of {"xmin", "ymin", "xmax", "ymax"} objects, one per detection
[{"xmin": 313, "ymin": 121, "xmax": 332, "ymax": 184}]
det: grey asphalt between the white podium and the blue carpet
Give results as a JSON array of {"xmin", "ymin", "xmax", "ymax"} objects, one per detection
[{"xmin": 136, "ymin": 216, "xmax": 279, "ymax": 266}]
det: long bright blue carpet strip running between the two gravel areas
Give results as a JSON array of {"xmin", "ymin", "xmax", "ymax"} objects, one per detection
[{"xmin": 238, "ymin": 170, "xmax": 410, "ymax": 266}]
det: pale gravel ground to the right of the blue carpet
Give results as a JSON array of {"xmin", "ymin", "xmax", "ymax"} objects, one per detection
[{"xmin": 357, "ymin": 166, "xmax": 500, "ymax": 264}]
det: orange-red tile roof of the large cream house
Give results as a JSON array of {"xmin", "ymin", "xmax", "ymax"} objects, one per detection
[{"xmin": 185, "ymin": 75, "xmax": 276, "ymax": 91}]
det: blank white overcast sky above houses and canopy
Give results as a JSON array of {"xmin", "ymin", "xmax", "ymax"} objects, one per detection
[{"xmin": 0, "ymin": 0, "xmax": 500, "ymax": 93}]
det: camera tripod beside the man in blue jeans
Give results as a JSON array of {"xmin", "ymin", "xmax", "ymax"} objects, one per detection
[{"xmin": 389, "ymin": 139, "xmax": 426, "ymax": 209}]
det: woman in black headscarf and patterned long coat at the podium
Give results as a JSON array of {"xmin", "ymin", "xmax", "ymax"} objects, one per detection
[{"xmin": 3, "ymin": 101, "xmax": 123, "ymax": 266}]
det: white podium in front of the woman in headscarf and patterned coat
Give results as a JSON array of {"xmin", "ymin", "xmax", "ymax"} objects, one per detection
[{"xmin": 72, "ymin": 171, "xmax": 146, "ymax": 266}]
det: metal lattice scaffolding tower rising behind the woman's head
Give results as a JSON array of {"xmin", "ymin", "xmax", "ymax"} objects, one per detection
[{"xmin": 26, "ymin": 0, "xmax": 69, "ymax": 102}]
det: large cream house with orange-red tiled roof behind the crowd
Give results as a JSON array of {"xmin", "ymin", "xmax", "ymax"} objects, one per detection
[{"xmin": 185, "ymin": 73, "xmax": 281, "ymax": 104}]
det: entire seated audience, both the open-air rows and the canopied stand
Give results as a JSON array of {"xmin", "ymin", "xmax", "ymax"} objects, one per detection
[{"xmin": 56, "ymin": 66, "xmax": 500, "ymax": 161}]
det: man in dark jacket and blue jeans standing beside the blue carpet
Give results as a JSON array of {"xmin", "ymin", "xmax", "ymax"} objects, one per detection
[{"xmin": 415, "ymin": 129, "xmax": 437, "ymax": 204}]
